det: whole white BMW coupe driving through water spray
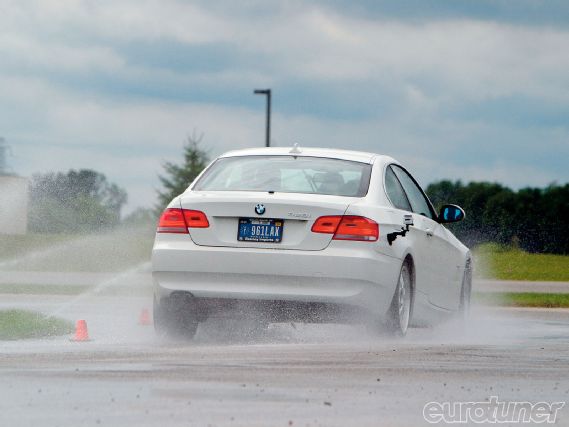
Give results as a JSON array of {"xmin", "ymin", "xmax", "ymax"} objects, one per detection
[{"xmin": 152, "ymin": 146, "xmax": 472, "ymax": 337}]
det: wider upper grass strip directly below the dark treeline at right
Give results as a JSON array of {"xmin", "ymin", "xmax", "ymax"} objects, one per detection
[{"xmin": 474, "ymin": 243, "xmax": 569, "ymax": 281}]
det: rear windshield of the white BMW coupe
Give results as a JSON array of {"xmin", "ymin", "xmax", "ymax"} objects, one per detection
[{"xmin": 193, "ymin": 156, "xmax": 371, "ymax": 197}]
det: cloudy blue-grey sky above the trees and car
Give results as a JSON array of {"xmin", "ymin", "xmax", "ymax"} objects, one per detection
[{"xmin": 0, "ymin": 0, "xmax": 569, "ymax": 211}]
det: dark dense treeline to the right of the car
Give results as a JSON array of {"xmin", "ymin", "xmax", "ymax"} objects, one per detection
[{"xmin": 426, "ymin": 180, "xmax": 569, "ymax": 254}]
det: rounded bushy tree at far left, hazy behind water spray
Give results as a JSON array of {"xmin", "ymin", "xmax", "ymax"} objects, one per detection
[{"xmin": 29, "ymin": 169, "xmax": 127, "ymax": 233}]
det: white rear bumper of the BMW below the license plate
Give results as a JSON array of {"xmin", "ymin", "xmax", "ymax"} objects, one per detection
[{"xmin": 152, "ymin": 234, "xmax": 401, "ymax": 320}]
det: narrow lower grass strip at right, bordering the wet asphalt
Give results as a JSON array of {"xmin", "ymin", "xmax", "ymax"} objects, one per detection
[{"xmin": 473, "ymin": 292, "xmax": 569, "ymax": 308}]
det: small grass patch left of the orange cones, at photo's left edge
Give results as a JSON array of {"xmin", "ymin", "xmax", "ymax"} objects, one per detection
[{"xmin": 0, "ymin": 310, "xmax": 74, "ymax": 340}]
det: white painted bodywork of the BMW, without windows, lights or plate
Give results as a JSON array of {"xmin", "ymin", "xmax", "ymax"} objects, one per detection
[{"xmin": 152, "ymin": 148, "xmax": 470, "ymax": 324}]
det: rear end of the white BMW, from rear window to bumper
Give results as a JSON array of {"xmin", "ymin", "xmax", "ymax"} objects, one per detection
[{"xmin": 152, "ymin": 149, "xmax": 400, "ymax": 321}]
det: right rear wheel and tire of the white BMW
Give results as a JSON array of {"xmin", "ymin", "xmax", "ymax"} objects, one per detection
[{"xmin": 386, "ymin": 261, "xmax": 413, "ymax": 337}]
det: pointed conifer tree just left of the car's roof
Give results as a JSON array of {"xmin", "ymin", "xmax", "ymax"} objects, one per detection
[{"xmin": 157, "ymin": 131, "xmax": 209, "ymax": 210}]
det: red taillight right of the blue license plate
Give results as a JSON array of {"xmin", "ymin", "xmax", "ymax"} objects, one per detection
[{"xmin": 312, "ymin": 215, "xmax": 379, "ymax": 242}]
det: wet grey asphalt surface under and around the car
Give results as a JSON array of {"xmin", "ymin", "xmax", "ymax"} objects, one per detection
[{"xmin": 0, "ymin": 295, "xmax": 569, "ymax": 427}]
